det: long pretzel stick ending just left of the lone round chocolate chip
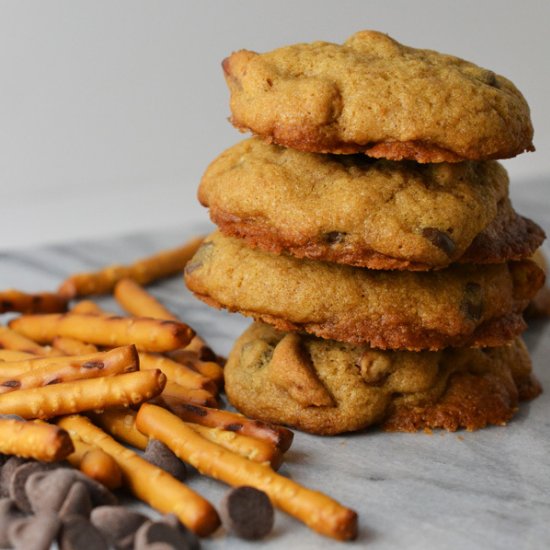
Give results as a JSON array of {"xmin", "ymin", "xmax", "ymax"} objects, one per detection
[{"xmin": 59, "ymin": 416, "xmax": 220, "ymax": 536}]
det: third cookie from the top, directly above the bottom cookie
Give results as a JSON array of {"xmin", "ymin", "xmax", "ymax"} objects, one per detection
[{"xmin": 185, "ymin": 233, "xmax": 544, "ymax": 350}]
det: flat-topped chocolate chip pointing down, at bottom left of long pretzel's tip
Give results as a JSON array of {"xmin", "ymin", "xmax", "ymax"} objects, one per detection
[{"xmin": 90, "ymin": 506, "xmax": 149, "ymax": 550}]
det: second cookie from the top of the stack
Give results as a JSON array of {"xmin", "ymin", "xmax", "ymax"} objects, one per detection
[{"xmin": 199, "ymin": 139, "xmax": 544, "ymax": 270}]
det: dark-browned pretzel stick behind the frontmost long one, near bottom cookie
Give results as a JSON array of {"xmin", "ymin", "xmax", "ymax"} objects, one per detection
[{"xmin": 167, "ymin": 403, "xmax": 294, "ymax": 453}]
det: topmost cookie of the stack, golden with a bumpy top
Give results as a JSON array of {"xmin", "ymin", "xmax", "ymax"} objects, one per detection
[{"xmin": 223, "ymin": 31, "xmax": 534, "ymax": 163}]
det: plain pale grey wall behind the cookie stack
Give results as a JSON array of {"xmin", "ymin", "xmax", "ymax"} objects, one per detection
[{"xmin": 0, "ymin": 0, "xmax": 550, "ymax": 249}]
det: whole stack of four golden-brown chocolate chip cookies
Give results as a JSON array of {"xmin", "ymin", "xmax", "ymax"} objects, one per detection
[{"xmin": 185, "ymin": 31, "xmax": 544, "ymax": 434}]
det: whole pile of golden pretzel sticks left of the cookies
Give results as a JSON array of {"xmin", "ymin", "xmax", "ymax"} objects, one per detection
[{"xmin": 0, "ymin": 237, "xmax": 357, "ymax": 540}]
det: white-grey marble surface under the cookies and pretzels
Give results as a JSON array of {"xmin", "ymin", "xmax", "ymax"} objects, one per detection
[{"xmin": 0, "ymin": 181, "xmax": 550, "ymax": 550}]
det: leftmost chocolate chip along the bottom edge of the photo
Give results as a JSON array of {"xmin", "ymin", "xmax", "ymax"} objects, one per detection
[{"xmin": 8, "ymin": 512, "xmax": 61, "ymax": 550}]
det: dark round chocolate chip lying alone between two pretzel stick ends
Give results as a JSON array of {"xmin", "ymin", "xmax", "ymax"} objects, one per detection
[{"xmin": 220, "ymin": 486, "xmax": 274, "ymax": 540}]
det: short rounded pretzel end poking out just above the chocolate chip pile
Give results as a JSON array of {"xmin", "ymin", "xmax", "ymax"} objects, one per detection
[{"xmin": 67, "ymin": 435, "xmax": 122, "ymax": 489}]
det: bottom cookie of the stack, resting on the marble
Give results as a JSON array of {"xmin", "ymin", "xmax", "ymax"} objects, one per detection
[{"xmin": 225, "ymin": 323, "xmax": 540, "ymax": 435}]
